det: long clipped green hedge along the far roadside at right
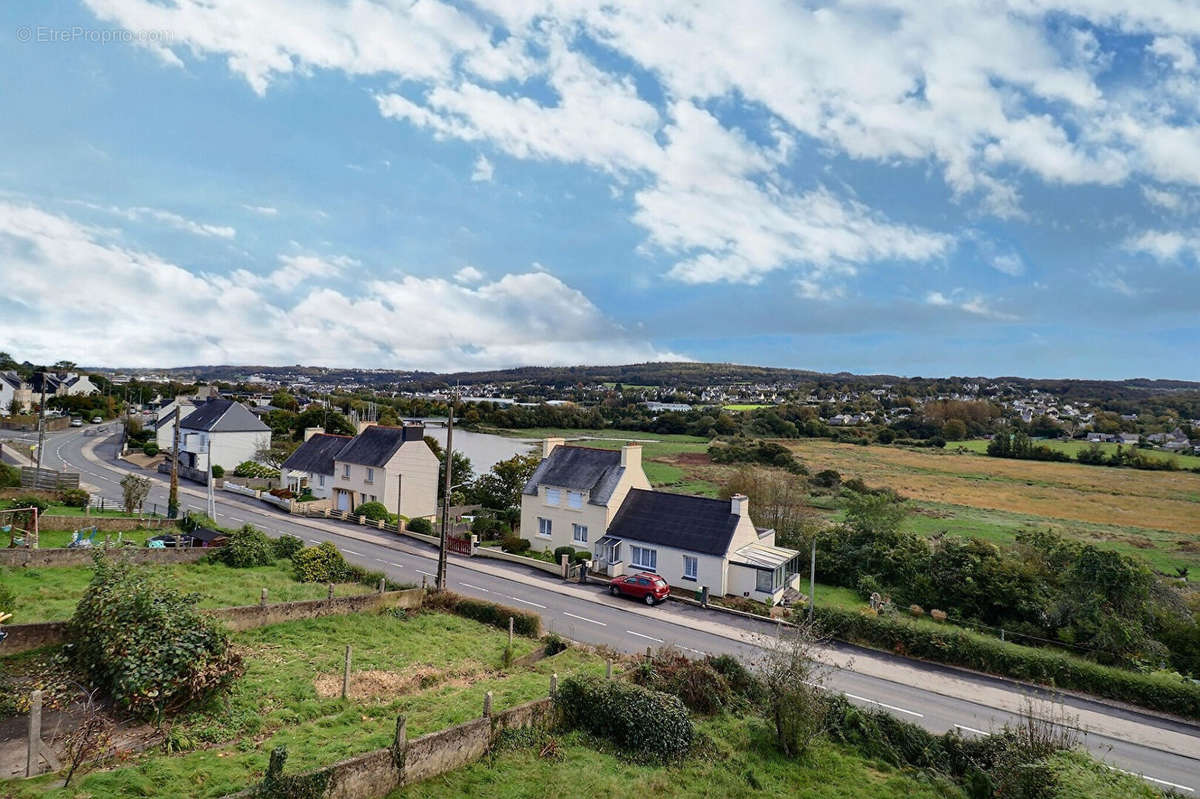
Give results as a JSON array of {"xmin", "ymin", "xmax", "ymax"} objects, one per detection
[{"xmin": 816, "ymin": 607, "xmax": 1200, "ymax": 719}]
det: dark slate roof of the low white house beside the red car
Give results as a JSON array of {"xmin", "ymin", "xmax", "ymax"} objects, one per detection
[{"xmin": 607, "ymin": 488, "xmax": 742, "ymax": 555}]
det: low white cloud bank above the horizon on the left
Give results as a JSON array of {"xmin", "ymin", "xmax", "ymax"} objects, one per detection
[{"xmin": 0, "ymin": 202, "xmax": 680, "ymax": 371}]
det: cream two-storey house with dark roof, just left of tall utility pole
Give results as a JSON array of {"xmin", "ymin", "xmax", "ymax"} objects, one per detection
[{"xmin": 326, "ymin": 425, "xmax": 439, "ymax": 518}]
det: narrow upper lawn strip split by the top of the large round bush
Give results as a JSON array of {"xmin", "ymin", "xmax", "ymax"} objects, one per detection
[{"xmin": 0, "ymin": 560, "xmax": 371, "ymax": 624}]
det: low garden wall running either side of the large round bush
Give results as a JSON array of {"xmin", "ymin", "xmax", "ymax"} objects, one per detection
[{"xmin": 0, "ymin": 585, "xmax": 425, "ymax": 655}]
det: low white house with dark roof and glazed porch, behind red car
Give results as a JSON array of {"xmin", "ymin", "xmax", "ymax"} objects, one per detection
[{"xmin": 593, "ymin": 488, "xmax": 800, "ymax": 605}]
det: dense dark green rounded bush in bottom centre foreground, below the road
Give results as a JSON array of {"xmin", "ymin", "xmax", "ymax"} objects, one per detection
[{"xmin": 554, "ymin": 674, "xmax": 695, "ymax": 761}]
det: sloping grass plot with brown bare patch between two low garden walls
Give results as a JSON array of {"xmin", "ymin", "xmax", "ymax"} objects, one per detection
[{"xmin": 0, "ymin": 613, "xmax": 604, "ymax": 799}]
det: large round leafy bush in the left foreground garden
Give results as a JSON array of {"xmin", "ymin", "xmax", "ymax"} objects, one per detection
[{"xmin": 65, "ymin": 554, "xmax": 242, "ymax": 719}]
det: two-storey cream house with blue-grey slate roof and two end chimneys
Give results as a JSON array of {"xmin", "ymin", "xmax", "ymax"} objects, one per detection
[{"xmin": 521, "ymin": 438, "xmax": 650, "ymax": 551}]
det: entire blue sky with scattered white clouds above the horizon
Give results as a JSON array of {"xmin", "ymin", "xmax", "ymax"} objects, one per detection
[{"xmin": 0, "ymin": 0, "xmax": 1200, "ymax": 379}]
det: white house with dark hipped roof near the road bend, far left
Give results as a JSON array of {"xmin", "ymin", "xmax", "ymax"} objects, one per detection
[{"xmin": 179, "ymin": 400, "xmax": 271, "ymax": 471}]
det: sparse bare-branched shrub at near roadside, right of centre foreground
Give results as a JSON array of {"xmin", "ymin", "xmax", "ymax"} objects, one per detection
[{"xmin": 756, "ymin": 623, "xmax": 829, "ymax": 757}]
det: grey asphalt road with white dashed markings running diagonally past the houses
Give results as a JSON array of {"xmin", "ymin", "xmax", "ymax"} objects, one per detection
[{"xmin": 28, "ymin": 429, "xmax": 1200, "ymax": 795}]
